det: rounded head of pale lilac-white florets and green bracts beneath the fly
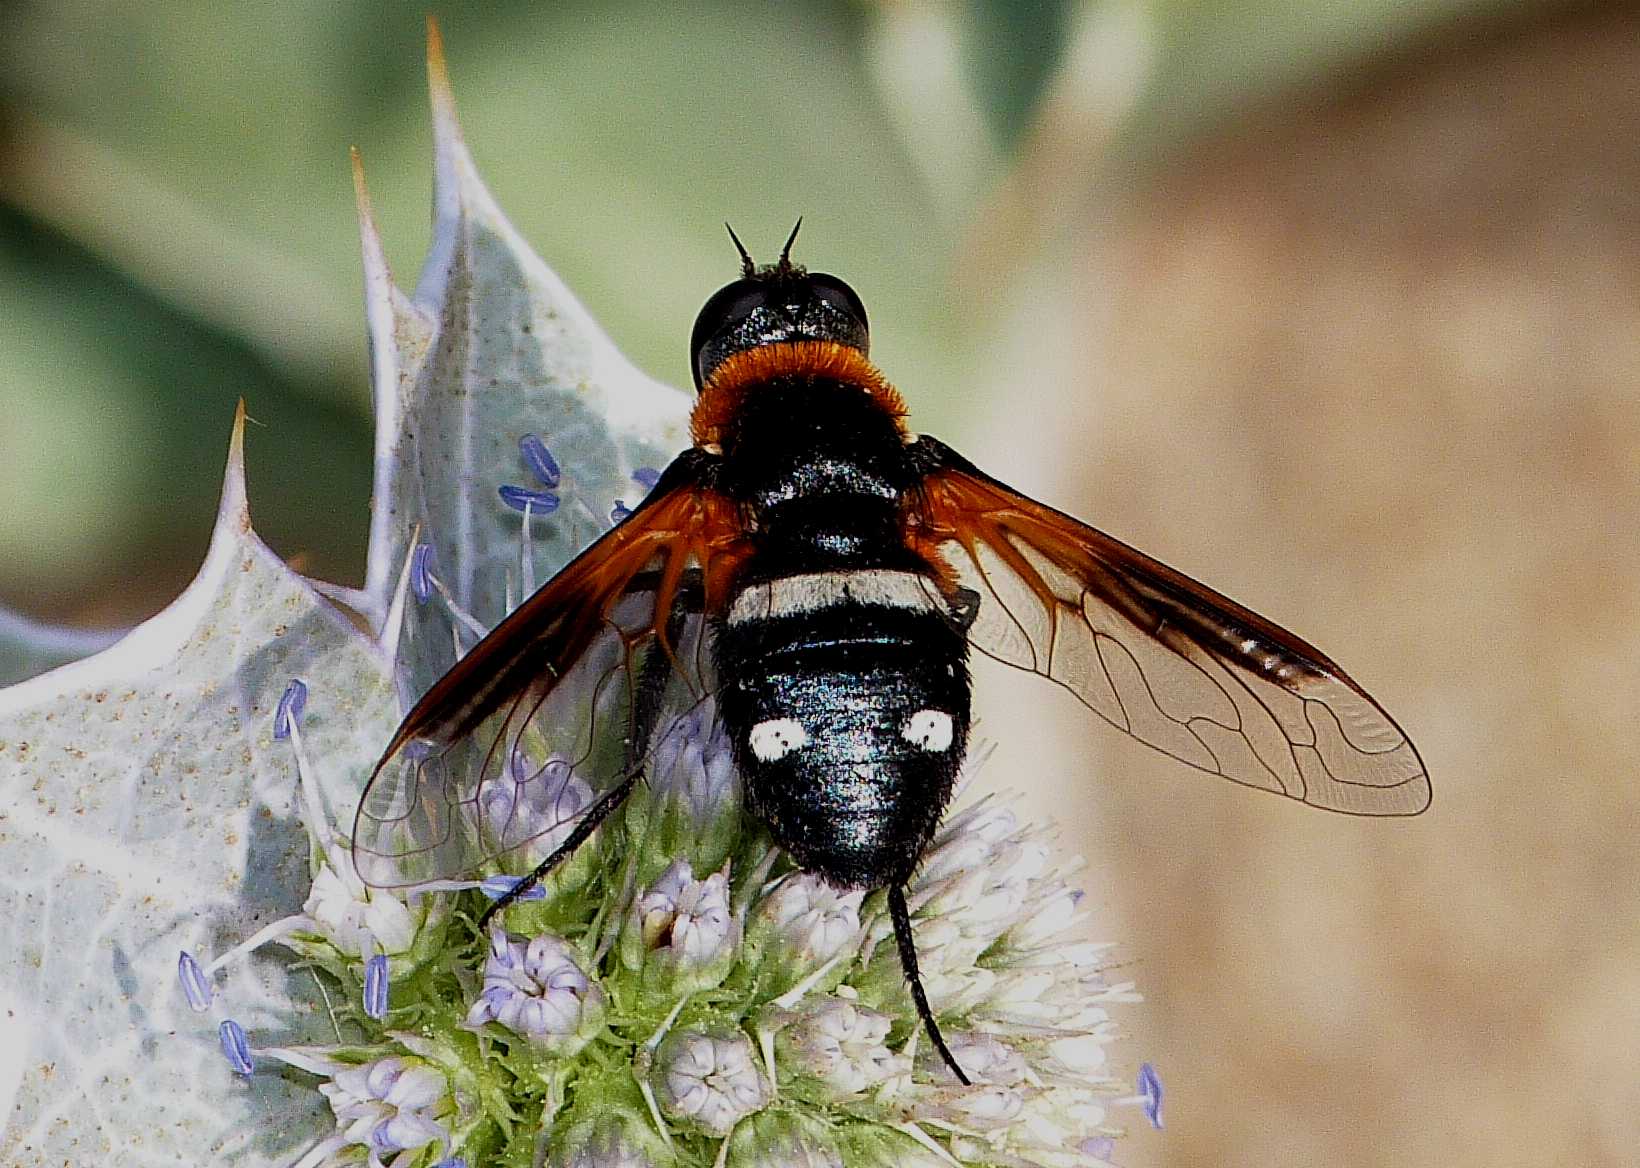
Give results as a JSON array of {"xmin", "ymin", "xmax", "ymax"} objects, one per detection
[{"xmin": 191, "ymin": 662, "xmax": 1159, "ymax": 1168}]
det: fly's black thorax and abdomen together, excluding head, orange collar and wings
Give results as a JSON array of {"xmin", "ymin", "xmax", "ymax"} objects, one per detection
[{"xmin": 713, "ymin": 379, "xmax": 969, "ymax": 887}]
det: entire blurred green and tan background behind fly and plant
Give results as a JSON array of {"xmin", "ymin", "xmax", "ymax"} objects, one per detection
[{"xmin": 0, "ymin": 0, "xmax": 1640, "ymax": 1168}]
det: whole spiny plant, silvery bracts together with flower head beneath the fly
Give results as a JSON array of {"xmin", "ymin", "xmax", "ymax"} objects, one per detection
[{"xmin": 0, "ymin": 27, "xmax": 1159, "ymax": 1168}]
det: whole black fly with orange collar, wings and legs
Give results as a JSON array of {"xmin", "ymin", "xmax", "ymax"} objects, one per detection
[{"xmin": 353, "ymin": 230, "xmax": 1430, "ymax": 1083}]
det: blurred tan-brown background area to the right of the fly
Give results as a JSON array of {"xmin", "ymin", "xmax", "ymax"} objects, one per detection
[{"xmin": 977, "ymin": 10, "xmax": 1640, "ymax": 1165}]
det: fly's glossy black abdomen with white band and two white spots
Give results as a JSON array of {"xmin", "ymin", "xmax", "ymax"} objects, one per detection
[{"xmin": 715, "ymin": 569, "xmax": 969, "ymax": 887}]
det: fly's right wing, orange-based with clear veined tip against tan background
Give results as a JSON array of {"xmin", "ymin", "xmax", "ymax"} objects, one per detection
[{"xmin": 912, "ymin": 438, "xmax": 1430, "ymax": 815}]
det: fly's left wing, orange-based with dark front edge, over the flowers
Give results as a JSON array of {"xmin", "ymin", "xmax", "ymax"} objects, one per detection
[{"xmin": 353, "ymin": 454, "xmax": 741, "ymax": 887}]
